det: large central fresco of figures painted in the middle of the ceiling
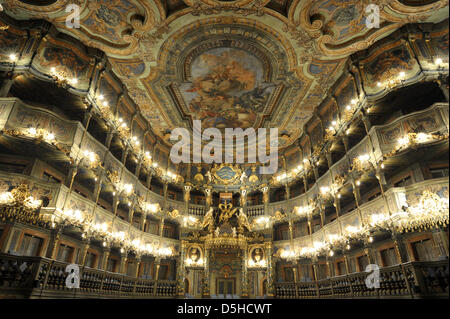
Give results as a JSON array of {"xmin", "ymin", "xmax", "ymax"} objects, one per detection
[{"xmin": 180, "ymin": 48, "xmax": 275, "ymax": 128}]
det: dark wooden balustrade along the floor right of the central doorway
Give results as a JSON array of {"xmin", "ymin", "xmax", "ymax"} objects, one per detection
[{"xmin": 275, "ymin": 260, "xmax": 449, "ymax": 299}]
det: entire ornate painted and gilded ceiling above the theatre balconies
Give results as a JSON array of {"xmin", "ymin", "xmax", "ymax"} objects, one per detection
[{"xmin": 3, "ymin": 0, "xmax": 448, "ymax": 147}]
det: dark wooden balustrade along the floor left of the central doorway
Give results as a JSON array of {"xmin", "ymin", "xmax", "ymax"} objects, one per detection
[{"xmin": 0, "ymin": 254, "xmax": 176, "ymax": 298}]
